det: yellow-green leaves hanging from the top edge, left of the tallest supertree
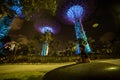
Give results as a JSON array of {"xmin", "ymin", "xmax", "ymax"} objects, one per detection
[{"xmin": 21, "ymin": 0, "xmax": 57, "ymax": 19}]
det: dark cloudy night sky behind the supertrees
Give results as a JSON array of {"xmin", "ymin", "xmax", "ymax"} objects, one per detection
[{"xmin": 0, "ymin": 0, "xmax": 120, "ymax": 48}]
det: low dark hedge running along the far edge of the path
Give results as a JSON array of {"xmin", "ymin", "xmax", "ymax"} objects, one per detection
[{"xmin": 0, "ymin": 53, "xmax": 120, "ymax": 63}]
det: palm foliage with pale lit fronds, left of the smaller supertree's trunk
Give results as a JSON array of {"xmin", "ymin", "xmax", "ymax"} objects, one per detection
[{"xmin": 3, "ymin": 40, "xmax": 35, "ymax": 57}]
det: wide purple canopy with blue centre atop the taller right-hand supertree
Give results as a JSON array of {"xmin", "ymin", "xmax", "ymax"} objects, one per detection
[{"xmin": 56, "ymin": 0, "xmax": 96, "ymax": 25}]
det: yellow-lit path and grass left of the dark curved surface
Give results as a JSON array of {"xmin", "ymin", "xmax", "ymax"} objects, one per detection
[{"xmin": 0, "ymin": 63, "xmax": 74, "ymax": 80}]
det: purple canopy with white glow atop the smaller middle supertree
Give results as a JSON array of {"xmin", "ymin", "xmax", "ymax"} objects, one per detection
[{"xmin": 34, "ymin": 20, "xmax": 60, "ymax": 34}]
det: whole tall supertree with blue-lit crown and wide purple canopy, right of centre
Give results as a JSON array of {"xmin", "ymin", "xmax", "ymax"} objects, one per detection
[{"xmin": 57, "ymin": 0, "xmax": 95, "ymax": 54}]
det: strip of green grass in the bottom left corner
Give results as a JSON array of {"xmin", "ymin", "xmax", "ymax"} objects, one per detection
[{"xmin": 0, "ymin": 71, "xmax": 45, "ymax": 80}]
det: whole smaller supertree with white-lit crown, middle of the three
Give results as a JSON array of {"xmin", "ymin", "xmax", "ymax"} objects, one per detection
[{"xmin": 35, "ymin": 19, "xmax": 60, "ymax": 56}]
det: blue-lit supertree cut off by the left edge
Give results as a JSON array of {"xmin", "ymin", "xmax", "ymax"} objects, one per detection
[{"xmin": 0, "ymin": 0, "xmax": 22, "ymax": 53}]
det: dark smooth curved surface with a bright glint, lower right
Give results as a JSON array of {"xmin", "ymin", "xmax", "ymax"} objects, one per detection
[{"xmin": 43, "ymin": 59, "xmax": 120, "ymax": 80}]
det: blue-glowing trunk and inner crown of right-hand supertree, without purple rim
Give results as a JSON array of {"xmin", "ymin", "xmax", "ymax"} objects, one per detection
[{"xmin": 66, "ymin": 5, "xmax": 91, "ymax": 53}]
